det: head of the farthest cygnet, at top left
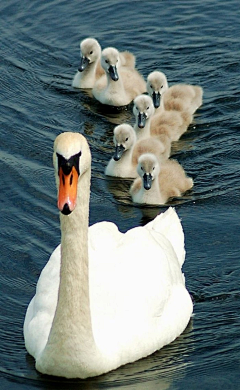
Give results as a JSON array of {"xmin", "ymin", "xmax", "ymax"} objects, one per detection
[{"xmin": 78, "ymin": 38, "xmax": 101, "ymax": 72}]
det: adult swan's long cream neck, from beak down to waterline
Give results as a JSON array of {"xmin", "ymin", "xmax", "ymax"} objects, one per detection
[{"xmin": 36, "ymin": 169, "xmax": 100, "ymax": 376}]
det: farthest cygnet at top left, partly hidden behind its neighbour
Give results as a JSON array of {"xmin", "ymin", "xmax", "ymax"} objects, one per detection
[{"xmin": 72, "ymin": 38, "xmax": 136, "ymax": 88}]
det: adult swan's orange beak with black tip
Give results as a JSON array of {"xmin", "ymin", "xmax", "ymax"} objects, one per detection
[{"xmin": 58, "ymin": 166, "xmax": 78, "ymax": 215}]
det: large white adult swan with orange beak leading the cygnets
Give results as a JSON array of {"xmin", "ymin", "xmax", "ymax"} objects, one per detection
[{"xmin": 24, "ymin": 132, "xmax": 192, "ymax": 378}]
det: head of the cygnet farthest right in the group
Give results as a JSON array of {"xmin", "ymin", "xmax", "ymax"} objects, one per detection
[{"xmin": 147, "ymin": 71, "xmax": 168, "ymax": 108}]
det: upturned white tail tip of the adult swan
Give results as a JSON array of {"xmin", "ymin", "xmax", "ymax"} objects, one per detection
[{"xmin": 146, "ymin": 207, "xmax": 185, "ymax": 267}]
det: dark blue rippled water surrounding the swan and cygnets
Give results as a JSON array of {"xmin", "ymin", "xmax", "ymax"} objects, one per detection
[{"xmin": 0, "ymin": 0, "xmax": 240, "ymax": 390}]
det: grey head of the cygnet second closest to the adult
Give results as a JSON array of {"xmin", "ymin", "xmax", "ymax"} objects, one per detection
[{"xmin": 113, "ymin": 123, "xmax": 136, "ymax": 161}]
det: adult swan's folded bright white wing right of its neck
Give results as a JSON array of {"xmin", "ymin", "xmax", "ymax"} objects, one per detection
[{"xmin": 89, "ymin": 216, "xmax": 186, "ymax": 351}]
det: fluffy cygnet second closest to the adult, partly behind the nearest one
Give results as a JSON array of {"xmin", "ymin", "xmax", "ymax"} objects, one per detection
[{"xmin": 105, "ymin": 123, "xmax": 171, "ymax": 178}]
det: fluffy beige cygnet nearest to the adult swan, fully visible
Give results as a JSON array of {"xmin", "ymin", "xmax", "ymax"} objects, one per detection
[{"xmin": 130, "ymin": 153, "xmax": 193, "ymax": 205}]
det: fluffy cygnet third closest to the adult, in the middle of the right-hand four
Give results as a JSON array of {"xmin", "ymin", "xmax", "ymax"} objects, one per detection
[{"xmin": 133, "ymin": 95, "xmax": 192, "ymax": 143}]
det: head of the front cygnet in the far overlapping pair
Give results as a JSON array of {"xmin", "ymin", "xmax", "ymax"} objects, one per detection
[{"xmin": 101, "ymin": 47, "xmax": 121, "ymax": 81}]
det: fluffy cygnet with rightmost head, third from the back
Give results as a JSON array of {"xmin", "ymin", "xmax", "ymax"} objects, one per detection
[{"xmin": 147, "ymin": 71, "xmax": 203, "ymax": 114}]
